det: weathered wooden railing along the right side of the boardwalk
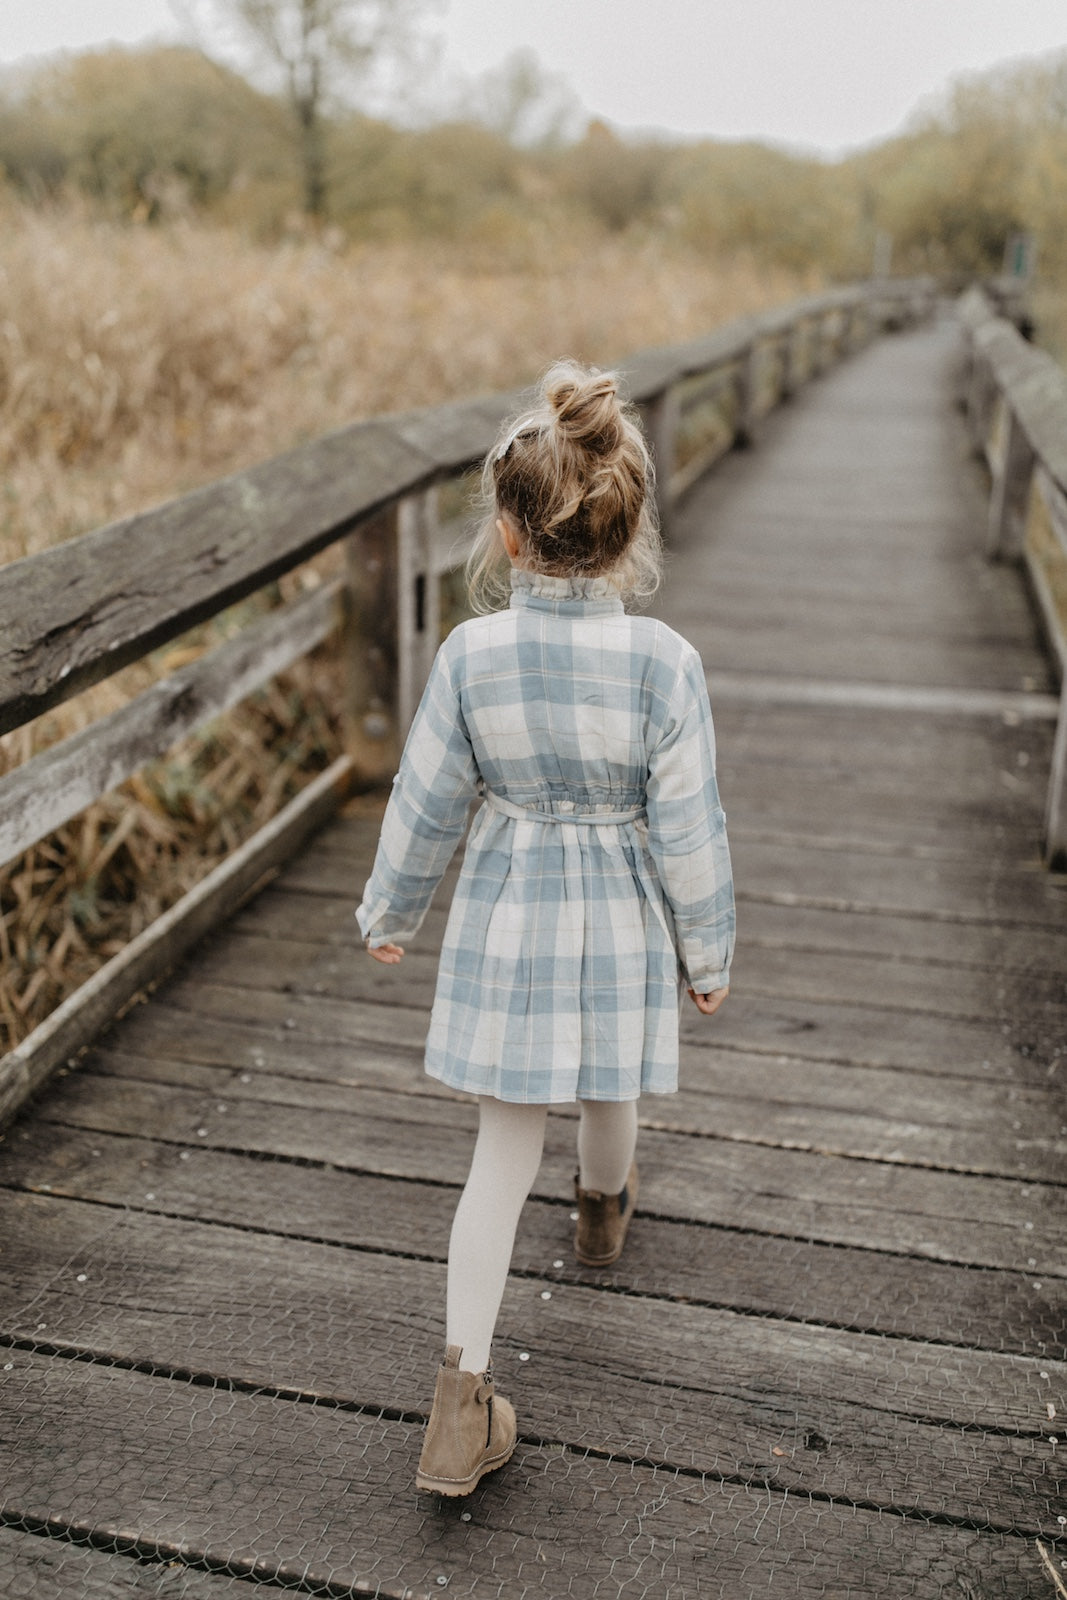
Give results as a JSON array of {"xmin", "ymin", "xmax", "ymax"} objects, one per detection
[{"xmin": 958, "ymin": 288, "xmax": 1067, "ymax": 870}]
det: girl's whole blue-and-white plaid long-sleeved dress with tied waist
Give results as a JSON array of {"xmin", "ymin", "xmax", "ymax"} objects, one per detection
[{"xmin": 357, "ymin": 570, "xmax": 734, "ymax": 1104}]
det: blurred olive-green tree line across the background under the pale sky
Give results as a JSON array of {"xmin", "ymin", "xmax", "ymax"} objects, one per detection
[{"xmin": 0, "ymin": 30, "xmax": 1067, "ymax": 283}]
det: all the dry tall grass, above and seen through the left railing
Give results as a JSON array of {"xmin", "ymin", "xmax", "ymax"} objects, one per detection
[{"xmin": 0, "ymin": 206, "xmax": 813, "ymax": 1045}]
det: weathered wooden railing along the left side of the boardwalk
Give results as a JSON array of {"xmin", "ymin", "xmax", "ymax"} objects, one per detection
[{"xmin": 0, "ymin": 280, "xmax": 934, "ymax": 1123}]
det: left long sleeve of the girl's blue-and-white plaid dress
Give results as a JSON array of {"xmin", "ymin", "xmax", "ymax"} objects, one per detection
[{"xmin": 355, "ymin": 646, "xmax": 478, "ymax": 947}]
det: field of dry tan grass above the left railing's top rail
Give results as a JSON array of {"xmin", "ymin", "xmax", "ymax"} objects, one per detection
[{"xmin": 0, "ymin": 206, "xmax": 806, "ymax": 560}]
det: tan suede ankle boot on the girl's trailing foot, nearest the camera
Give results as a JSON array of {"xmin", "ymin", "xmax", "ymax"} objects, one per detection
[{"xmin": 414, "ymin": 1344, "xmax": 515, "ymax": 1494}]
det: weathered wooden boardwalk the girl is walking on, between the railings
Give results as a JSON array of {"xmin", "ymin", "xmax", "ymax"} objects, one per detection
[{"xmin": 0, "ymin": 312, "xmax": 1067, "ymax": 1600}]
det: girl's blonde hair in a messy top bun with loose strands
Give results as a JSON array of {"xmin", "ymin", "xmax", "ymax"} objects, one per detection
[{"xmin": 467, "ymin": 362, "xmax": 662, "ymax": 611}]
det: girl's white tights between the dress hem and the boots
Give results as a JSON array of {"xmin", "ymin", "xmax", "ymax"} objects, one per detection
[{"xmin": 446, "ymin": 1094, "xmax": 637, "ymax": 1373}]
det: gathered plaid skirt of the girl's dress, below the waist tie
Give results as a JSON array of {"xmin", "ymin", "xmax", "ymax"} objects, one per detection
[{"xmin": 426, "ymin": 805, "xmax": 680, "ymax": 1104}]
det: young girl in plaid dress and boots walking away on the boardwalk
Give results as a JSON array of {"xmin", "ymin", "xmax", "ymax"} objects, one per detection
[{"xmin": 357, "ymin": 363, "xmax": 734, "ymax": 1494}]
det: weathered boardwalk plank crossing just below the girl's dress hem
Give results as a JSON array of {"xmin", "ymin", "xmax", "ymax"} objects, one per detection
[{"xmin": 27, "ymin": 1072, "xmax": 1067, "ymax": 1277}]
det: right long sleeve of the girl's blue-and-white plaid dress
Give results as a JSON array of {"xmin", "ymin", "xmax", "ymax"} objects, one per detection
[{"xmin": 648, "ymin": 651, "xmax": 734, "ymax": 994}]
